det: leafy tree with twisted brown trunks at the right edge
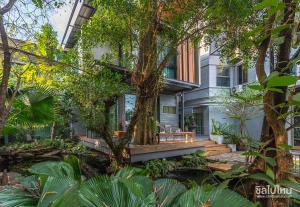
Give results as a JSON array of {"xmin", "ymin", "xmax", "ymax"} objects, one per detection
[{"xmin": 206, "ymin": 0, "xmax": 300, "ymax": 206}]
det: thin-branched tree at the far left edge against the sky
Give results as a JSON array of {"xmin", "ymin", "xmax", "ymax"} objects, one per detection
[{"xmin": 0, "ymin": 0, "xmax": 61, "ymax": 135}]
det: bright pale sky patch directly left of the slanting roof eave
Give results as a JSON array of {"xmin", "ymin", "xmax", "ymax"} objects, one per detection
[{"xmin": 50, "ymin": 1, "xmax": 74, "ymax": 43}]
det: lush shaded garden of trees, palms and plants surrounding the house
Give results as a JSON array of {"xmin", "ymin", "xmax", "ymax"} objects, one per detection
[{"xmin": 0, "ymin": 0, "xmax": 300, "ymax": 207}]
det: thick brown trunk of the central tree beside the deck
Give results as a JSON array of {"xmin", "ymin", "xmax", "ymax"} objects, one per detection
[{"xmin": 126, "ymin": 1, "xmax": 162, "ymax": 145}]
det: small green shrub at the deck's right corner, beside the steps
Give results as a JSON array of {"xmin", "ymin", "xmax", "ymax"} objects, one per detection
[{"xmin": 181, "ymin": 151, "xmax": 208, "ymax": 168}]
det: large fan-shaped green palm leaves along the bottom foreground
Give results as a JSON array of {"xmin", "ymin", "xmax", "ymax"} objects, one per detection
[{"xmin": 0, "ymin": 157, "xmax": 253, "ymax": 207}]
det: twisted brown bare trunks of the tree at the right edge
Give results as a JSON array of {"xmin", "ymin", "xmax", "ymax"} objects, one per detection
[{"xmin": 256, "ymin": 0, "xmax": 296, "ymax": 207}]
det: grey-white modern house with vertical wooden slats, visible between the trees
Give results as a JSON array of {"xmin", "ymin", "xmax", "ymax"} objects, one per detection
[{"xmin": 62, "ymin": 1, "xmax": 300, "ymax": 149}]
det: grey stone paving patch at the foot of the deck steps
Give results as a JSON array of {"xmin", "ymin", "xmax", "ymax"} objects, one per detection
[{"xmin": 207, "ymin": 151, "xmax": 246, "ymax": 164}]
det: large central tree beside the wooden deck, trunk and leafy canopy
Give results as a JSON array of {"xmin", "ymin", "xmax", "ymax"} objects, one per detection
[{"xmin": 81, "ymin": 0, "xmax": 216, "ymax": 144}]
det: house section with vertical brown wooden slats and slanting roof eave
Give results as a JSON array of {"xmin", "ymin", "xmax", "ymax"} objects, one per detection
[{"xmin": 62, "ymin": 1, "xmax": 200, "ymax": 137}]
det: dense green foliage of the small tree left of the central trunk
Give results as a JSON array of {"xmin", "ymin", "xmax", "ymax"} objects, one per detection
[{"xmin": 67, "ymin": 65, "xmax": 129, "ymax": 133}]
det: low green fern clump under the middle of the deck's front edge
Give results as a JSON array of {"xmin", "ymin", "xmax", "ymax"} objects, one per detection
[{"xmin": 145, "ymin": 159, "xmax": 176, "ymax": 177}]
